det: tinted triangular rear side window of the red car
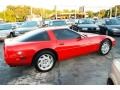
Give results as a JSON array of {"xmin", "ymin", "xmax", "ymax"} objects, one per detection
[{"xmin": 23, "ymin": 32, "xmax": 50, "ymax": 42}]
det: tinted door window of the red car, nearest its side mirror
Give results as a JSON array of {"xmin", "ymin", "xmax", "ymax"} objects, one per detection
[{"xmin": 53, "ymin": 29, "xmax": 80, "ymax": 40}]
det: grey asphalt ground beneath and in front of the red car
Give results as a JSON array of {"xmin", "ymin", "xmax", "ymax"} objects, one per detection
[{"xmin": 0, "ymin": 37, "xmax": 120, "ymax": 85}]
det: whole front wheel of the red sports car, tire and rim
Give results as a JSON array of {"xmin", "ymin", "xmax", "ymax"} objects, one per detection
[{"xmin": 99, "ymin": 39, "xmax": 111, "ymax": 55}]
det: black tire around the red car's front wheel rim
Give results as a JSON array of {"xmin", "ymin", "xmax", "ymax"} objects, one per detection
[{"xmin": 99, "ymin": 39, "xmax": 112, "ymax": 55}]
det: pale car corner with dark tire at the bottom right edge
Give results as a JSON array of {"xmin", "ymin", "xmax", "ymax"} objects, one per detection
[{"xmin": 107, "ymin": 59, "xmax": 120, "ymax": 85}]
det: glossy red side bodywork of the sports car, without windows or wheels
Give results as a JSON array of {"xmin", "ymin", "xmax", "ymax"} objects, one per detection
[{"xmin": 4, "ymin": 27, "xmax": 115, "ymax": 66}]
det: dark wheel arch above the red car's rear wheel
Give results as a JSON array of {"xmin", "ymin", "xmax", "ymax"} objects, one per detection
[{"xmin": 31, "ymin": 48, "xmax": 58, "ymax": 65}]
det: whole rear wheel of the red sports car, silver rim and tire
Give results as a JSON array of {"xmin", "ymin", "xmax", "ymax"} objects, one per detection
[{"xmin": 34, "ymin": 51, "xmax": 56, "ymax": 72}]
